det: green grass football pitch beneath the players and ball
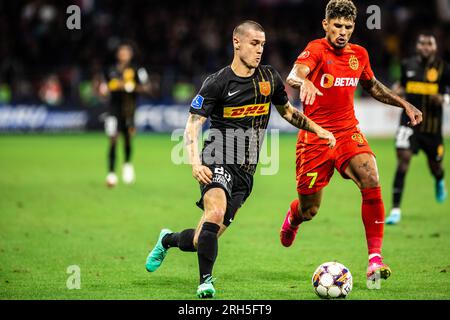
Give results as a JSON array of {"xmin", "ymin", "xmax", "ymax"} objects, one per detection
[{"xmin": 0, "ymin": 134, "xmax": 450, "ymax": 300}]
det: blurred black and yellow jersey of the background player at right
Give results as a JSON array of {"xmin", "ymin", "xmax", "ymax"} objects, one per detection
[{"xmin": 400, "ymin": 56, "xmax": 450, "ymax": 135}]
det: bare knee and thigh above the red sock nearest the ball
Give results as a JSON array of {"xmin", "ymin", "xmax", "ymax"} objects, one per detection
[{"xmin": 344, "ymin": 153, "xmax": 380, "ymax": 189}]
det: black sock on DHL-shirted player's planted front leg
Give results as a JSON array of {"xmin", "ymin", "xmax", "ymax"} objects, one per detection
[{"xmin": 197, "ymin": 222, "xmax": 220, "ymax": 284}]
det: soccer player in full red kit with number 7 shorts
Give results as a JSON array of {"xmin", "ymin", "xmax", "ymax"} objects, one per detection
[{"xmin": 280, "ymin": 0, "xmax": 422, "ymax": 288}]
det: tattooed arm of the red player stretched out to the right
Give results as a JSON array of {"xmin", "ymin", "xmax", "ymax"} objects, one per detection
[{"xmin": 360, "ymin": 77, "xmax": 422, "ymax": 126}]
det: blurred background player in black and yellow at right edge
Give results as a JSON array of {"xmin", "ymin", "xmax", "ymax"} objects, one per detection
[{"xmin": 386, "ymin": 33, "xmax": 450, "ymax": 224}]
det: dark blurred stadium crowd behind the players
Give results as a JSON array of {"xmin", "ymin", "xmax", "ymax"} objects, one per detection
[{"xmin": 0, "ymin": 0, "xmax": 450, "ymax": 107}]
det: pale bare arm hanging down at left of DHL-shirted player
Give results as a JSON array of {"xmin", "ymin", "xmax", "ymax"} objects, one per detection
[{"xmin": 184, "ymin": 113, "xmax": 212, "ymax": 184}]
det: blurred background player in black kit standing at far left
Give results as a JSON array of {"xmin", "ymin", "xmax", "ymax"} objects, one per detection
[{"xmin": 101, "ymin": 42, "xmax": 151, "ymax": 187}]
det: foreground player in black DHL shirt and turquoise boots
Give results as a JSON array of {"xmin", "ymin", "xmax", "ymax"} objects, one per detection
[{"xmin": 146, "ymin": 21, "xmax": 336, "ymax": 298}]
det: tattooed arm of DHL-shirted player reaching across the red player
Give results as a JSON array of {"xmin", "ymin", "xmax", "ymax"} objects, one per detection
[{"xmin": 275, "ymin": 101, "xmax": 336, "ymax": 148}]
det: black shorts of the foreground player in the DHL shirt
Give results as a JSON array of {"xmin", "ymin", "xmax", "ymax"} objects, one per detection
[{"xmin": 197, "ymin": 164, "xmax": 253, "ymax": 227}]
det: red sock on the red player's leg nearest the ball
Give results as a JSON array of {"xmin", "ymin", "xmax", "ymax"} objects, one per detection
[{"xmin": 361, "ymin": 187, "xmax": 384, "ymax": 255}]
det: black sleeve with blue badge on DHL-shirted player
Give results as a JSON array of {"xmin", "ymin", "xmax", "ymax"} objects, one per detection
[{"xmin": 189, "ymin": 76, "xmax": 220, "ymax": 118}]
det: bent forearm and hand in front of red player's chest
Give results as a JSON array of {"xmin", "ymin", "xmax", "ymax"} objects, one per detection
[{"xmin": 286, "ymin": 63, "xmax": 323, "ymax": 104}]
